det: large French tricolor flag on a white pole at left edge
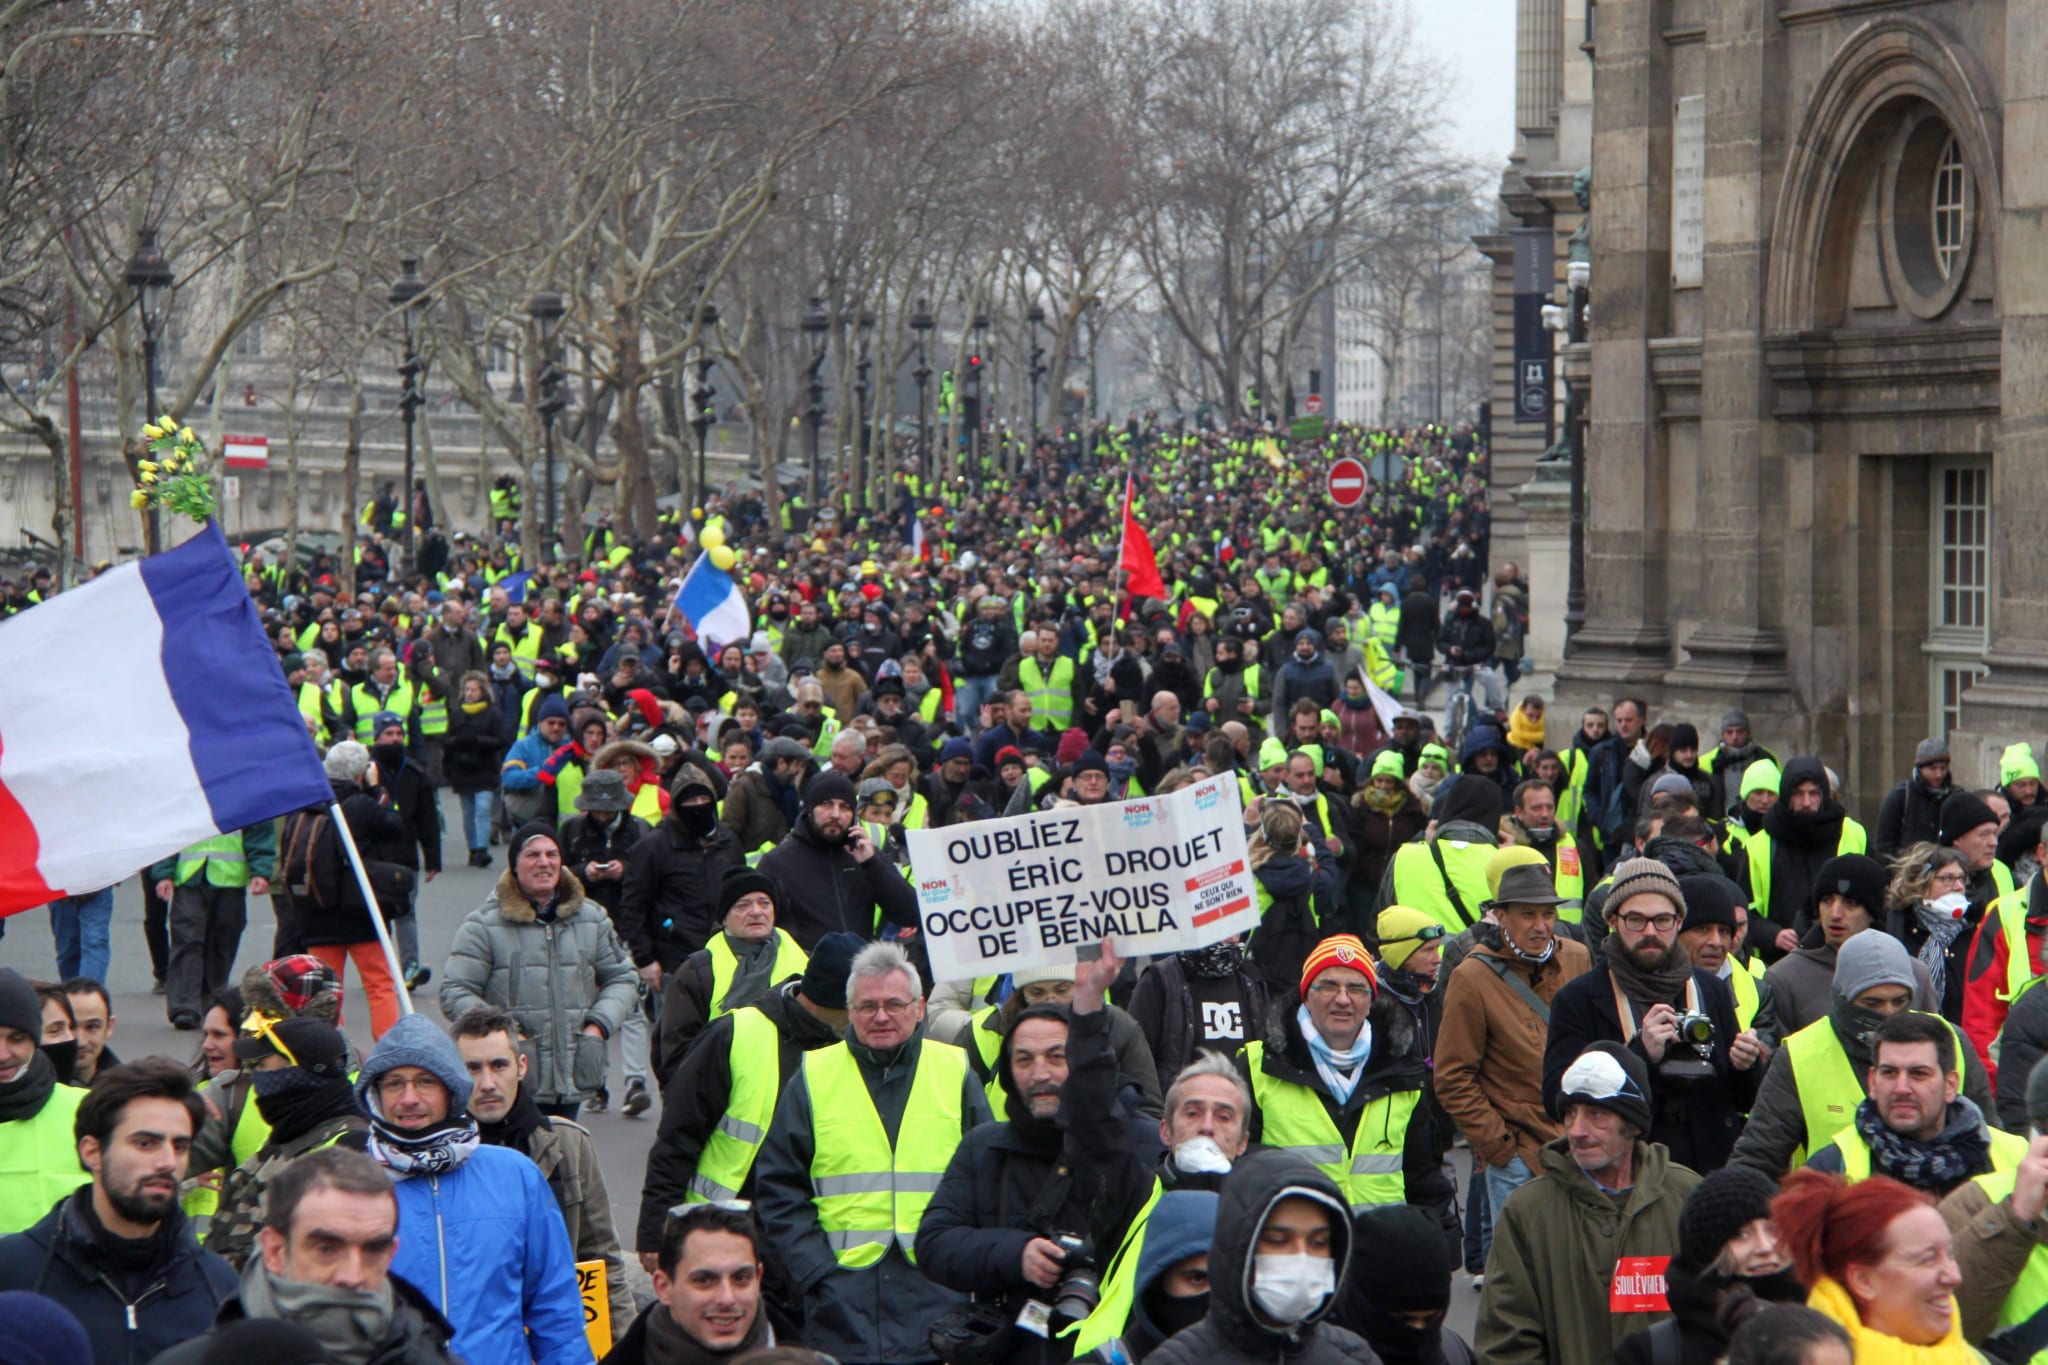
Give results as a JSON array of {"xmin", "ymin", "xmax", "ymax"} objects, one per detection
[{"xmin": 0, "ymin": 522, "xmax": 334, "ymax": 915}]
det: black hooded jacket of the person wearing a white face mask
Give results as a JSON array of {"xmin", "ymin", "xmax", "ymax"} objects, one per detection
[{"xmin": 1133, "ymin": 1148, "xmax": 1378, "ymax": 1365}]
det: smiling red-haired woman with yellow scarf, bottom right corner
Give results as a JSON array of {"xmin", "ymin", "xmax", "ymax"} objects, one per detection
[{"xmin": 1772, "ymin": 1171, "xmax": 1980, "ymax": 1365}]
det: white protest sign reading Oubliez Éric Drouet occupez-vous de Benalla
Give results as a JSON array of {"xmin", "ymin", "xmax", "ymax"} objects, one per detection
[{"xmin": 905, "ymin": 778, "xmax": 1260, "ymax": 980}]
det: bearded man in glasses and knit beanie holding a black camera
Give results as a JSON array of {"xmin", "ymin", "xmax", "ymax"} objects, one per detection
[{"xmin": 1542, "ymin": 857, "xmax": 1769, "ymax": 1173}]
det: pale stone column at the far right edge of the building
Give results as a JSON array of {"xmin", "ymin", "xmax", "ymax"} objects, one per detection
[{"xmin": 1950, "ymin": 4, "xmax": 2048, "ymax": 784}]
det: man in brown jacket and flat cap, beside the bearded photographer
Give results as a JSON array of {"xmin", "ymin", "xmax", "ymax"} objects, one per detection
[{"xmin": 1436, "ymin": 864, "xmax": 1591, "ymax": 1236}]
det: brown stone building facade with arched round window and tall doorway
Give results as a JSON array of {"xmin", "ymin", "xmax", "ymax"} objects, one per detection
[{"xmin": 1556, "ymin": 0, "xmax": 2023, "ymax": 810}]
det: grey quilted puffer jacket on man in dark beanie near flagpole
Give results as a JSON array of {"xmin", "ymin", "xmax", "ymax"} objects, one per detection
[{"xmin": 440, "ymin": 868, "xmax": 639, "ymax": 1105}]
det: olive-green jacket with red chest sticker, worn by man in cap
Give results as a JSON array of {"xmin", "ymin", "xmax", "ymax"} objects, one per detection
[{"xmin": 1473, "ymin": 1138, "xmax": 1700, "ymax": 1365}]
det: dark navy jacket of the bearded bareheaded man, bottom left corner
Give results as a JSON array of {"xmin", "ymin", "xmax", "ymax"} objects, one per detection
[{"xmin": 0, "ymin": 1185, "xmax": 238, "ymax": 1365}]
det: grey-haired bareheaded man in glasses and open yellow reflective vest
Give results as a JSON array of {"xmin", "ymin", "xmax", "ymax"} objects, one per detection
[{"xmin": 754, "ymin": 941, "xmax": 989, "ymax": 1365}]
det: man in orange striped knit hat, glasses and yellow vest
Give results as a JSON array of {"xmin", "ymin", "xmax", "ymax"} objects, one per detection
[{"xmin": 1237, "ymin": 933, "xmax": 1450, "ymax": 1214}]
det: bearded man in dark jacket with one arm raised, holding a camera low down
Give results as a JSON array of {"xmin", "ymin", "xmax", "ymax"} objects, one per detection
[{"xmin": 918, "ymin": 943, "xmax": 1153, "ymax": 1365}]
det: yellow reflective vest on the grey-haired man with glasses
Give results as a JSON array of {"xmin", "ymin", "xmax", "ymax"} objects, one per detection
[{"xmin": 803, "ymin": 1038, "xmax": 967, "ymax": 1271}]
